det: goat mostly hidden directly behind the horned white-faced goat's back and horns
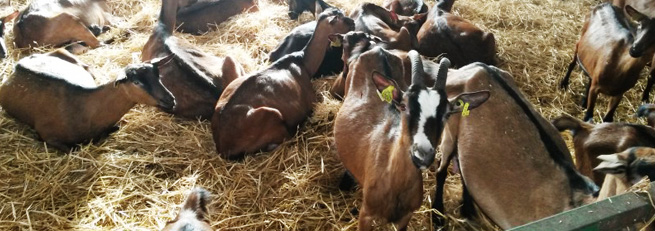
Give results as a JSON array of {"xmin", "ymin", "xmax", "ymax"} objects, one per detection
[{"xmin": 330, "ymin": 29, "xmax": 438, "ymax": 99}]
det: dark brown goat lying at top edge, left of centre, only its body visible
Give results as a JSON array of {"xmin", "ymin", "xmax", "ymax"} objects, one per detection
[{"xmin": 177, "ymin": 0, "xmax": 259, "ymax": 34}]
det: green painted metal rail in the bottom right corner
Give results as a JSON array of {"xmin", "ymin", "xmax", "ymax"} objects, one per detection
[{"xmin": 510, "ymin": 182, "xmax": 655, "ymax": 231}]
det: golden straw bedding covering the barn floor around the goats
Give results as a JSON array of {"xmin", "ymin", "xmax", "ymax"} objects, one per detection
[{"xmin": 0, "ymin": 0, "xmax": 645, "ymax": 230}]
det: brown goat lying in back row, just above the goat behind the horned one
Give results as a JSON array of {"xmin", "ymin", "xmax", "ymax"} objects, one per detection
[{"xmin": 350, "ymin": 3, "xmax": 420, "ymax": 51}]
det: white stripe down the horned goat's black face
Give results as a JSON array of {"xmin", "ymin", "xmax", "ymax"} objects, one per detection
[{"xmin": 412, "ymin": 89, "xmax": 441, "ymax": 168}]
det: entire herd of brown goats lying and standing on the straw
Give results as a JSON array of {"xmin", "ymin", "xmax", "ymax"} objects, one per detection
[{"xmin": 0, "ymin": 0, "xmax": 655, "ymax": 230}]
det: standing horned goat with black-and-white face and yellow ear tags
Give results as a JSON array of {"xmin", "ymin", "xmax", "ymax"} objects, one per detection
[{"xmin": 334, "ymin": 47, "xmax": 489, "ymax": 230}]
